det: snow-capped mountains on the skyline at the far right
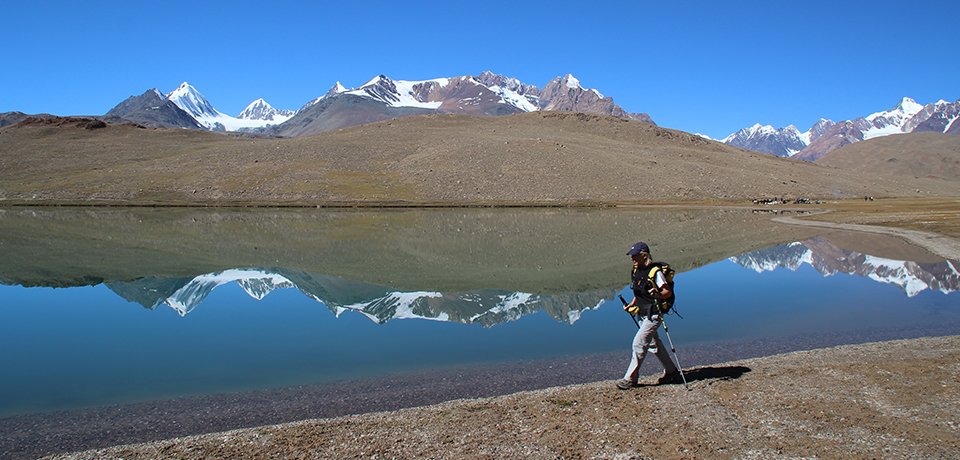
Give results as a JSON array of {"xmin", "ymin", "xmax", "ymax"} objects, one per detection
[{"xmin": 723, "ymin": 97, "xmax": 960, "ymax": 161}]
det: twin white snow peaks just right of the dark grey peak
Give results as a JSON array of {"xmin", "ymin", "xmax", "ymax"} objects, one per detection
[{"xmin": 167, "ymin": 82, "xmax": 293, "ymax": 131}]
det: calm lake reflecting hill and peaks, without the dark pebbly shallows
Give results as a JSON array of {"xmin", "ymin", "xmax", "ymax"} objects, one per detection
[{"xmin": 0, "ymin": 209, "xmax": 960, "ymax": 417}]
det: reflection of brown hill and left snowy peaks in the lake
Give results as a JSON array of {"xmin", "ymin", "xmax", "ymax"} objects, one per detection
[{"xmin": 0, "ymin": 208, "xmax": 811, "ymax": 326}]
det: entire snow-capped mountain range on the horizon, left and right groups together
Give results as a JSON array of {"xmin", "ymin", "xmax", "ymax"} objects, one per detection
[{"xmin": 0, "ymin": 67, "xmax": 960, "ymax": 161}]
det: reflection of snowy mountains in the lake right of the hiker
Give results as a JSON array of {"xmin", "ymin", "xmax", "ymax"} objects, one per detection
[{"xmin": 730, "ymin": 238, "xmax": 960, "ymax": 297}]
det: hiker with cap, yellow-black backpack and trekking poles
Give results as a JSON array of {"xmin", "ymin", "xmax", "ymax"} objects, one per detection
[{"xmin": 617, "ymin": 241, "xmax": 680, "ymax": 390}]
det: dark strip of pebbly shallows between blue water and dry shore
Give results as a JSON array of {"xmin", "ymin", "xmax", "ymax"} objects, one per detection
[{"xmin": 7, "ymin": 324, "xmax": 960, "ymax": 458}]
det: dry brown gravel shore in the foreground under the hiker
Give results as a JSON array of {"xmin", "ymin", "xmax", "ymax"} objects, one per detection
[{"xmin": 47, "ymin": 335, "xmax": 960, "ymax": 459}]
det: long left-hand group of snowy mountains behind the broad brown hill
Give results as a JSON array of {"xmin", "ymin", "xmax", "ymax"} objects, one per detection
[{"xmin": 99, "ymin": 71, "xmax": 653, "ymax": 137}]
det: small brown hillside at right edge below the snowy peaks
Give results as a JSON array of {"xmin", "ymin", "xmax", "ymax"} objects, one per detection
[{"xmin": 817, "ymin": 133, "xmax": 960, "ymax": 181}]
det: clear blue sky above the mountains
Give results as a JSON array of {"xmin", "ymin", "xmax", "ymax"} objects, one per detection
[{"xmin": 0, "ymin": 0, "xmax": 960, "ymax": 137}]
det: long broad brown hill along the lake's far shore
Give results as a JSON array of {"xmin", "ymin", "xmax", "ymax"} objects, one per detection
[{"xmin": 0, "ymin": 112, "xmax": 958, "ymax": 205}]
